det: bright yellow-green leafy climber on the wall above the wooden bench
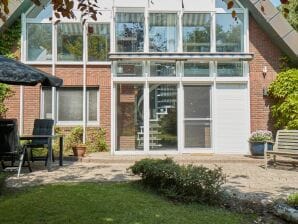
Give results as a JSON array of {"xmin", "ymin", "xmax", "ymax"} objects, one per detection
[{"xmin": 269, "ymin": 69, "xmax": 298, "ymax": 129}]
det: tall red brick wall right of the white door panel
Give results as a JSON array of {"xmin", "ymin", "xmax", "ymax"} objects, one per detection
[{"xmin": 249, "ymin": 16, "xmax": 281, "ymax": 132}]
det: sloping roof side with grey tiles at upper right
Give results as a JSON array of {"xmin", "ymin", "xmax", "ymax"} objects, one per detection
[{"xmin": 240, "ymin": 0, "xmax": 298, "ymax": 64}]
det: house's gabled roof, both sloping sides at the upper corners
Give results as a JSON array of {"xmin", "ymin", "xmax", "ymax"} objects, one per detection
[{"xmin": 0, "ymin": 0, "xmax": 298, "ymax": 64}]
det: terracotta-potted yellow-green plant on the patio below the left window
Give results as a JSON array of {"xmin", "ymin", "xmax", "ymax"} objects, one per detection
[{"xmin": 68, "ymin": 126, "xmax": 87, "ymax": 157}]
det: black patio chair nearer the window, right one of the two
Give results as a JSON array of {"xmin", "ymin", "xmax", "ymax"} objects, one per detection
[{"xmin": 26, "ymin": 119, "xmax": 55, "ymax": 166}]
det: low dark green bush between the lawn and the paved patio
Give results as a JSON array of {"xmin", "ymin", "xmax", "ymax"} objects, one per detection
[{"xmin": 130, "ymin": 158, "xmax": 225, "ymax": 204}]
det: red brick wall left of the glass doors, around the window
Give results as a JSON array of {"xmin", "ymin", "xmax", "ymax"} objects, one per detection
[{"xmin": 7, "ymin": 65, "xmax": 111, "ymax": 146}]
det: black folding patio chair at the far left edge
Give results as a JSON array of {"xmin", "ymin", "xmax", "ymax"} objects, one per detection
[{"xmin": 0, "ymin": 119, "xmax": 32, "ymax": 177}]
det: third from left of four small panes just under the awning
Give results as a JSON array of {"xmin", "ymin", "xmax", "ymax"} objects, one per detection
[{"xmin": 184, "ymin": 62, "xmax": 210, "ymax": 77}]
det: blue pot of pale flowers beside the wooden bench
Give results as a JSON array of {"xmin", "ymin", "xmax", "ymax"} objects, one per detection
[{"xmin": 249, "ymin": 130, "xmax": 273, "ymax": 156}]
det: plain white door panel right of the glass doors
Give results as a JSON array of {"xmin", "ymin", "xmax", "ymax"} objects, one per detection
[{"xmin": 215, "ymin": 84, "xmax": 250, "ymax": 154}]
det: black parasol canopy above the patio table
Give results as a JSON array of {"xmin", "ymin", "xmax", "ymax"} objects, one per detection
[{"xmin": 0, "ymin": 56, "xmax": 63, "ymax": 87}]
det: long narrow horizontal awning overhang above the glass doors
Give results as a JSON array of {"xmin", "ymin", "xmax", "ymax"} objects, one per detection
[{"xmin": 109, "ymin": 52, "xmax": 253, "ymax": 61}]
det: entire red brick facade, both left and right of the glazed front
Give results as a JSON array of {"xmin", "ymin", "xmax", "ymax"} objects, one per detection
[{"xmin": 7, "ymin": 16, "xmax": 282, "ymax": 152}]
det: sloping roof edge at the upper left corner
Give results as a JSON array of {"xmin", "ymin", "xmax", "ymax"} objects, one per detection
[{"xmin": 0, "ymin": 0, "xmax": 32, "ymax": 30}]
